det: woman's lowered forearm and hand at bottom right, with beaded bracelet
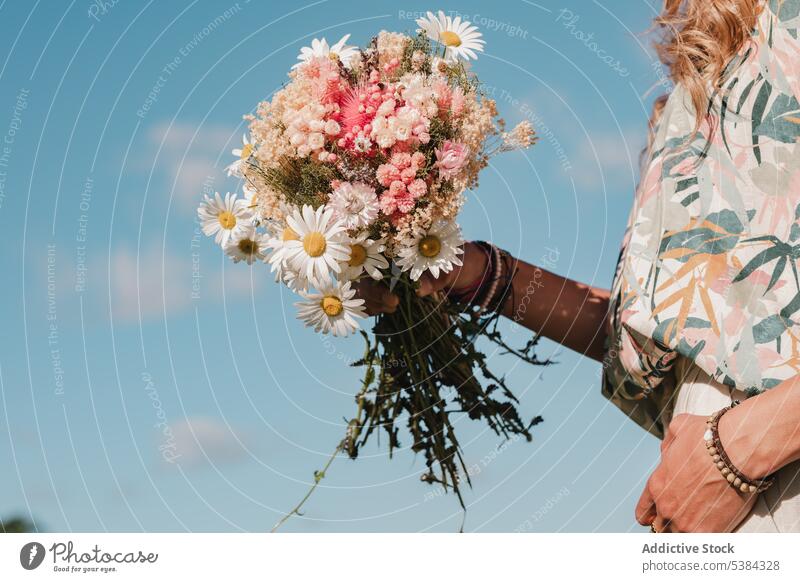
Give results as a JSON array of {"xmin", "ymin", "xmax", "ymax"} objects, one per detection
[{"xmin": 636, "ymin": 376, "xmax": 800, "ymax": 532}]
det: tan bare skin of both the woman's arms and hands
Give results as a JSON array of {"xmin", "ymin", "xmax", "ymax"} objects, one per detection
[{"xmin": 358, "ymin": 243, "xmax": 800, "ymax": 532}]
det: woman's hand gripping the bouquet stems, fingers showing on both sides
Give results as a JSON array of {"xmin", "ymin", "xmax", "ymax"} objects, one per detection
[{"xmin": 356, "ymin": 242, "xmax": 488, "ymax": 315}]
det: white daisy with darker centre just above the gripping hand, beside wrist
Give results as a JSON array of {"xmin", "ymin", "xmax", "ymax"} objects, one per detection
[{"xmin": 395, "ymin": 220, "xmax": 464, "ymax": 281}]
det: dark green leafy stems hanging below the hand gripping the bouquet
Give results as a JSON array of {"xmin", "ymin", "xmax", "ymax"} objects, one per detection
[{"xmin": 342, "ymin": 279, "xmax": 550, "ymax": 506}]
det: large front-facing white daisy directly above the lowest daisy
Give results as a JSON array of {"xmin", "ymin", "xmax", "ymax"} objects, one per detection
[{"xmin": 284, "ymin": 204, "xmax": 349, "ymax": 284}]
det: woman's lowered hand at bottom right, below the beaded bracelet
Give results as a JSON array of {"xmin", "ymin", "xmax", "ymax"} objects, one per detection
[{"xmin": 636, "ymin": 413, "xmax": 757, "ymax": 532}]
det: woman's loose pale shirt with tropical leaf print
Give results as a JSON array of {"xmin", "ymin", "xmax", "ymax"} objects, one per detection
[{"xmin": 603, "ymin": 0, "xmax": 800, "ymax": 436}]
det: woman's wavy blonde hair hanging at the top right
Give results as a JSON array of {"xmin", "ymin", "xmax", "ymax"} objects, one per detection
[{"xmin": 650, "ymin": 0, "xmax": 762, "ymax": 133}]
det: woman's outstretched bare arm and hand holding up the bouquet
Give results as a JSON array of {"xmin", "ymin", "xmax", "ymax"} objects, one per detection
[{"xmin": 359, "ymin": 243, "xmax": 609, "ymax": 361}]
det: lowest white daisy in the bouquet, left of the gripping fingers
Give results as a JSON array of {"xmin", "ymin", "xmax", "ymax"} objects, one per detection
[{"xmin": 295, "ymin": 281, "xmax": 365, "ymax": 336}]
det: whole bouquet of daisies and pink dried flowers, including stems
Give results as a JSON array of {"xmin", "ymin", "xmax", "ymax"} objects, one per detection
[{"xmin": 198, "ymin": 11, "xmax": 541, "ymax": 524}]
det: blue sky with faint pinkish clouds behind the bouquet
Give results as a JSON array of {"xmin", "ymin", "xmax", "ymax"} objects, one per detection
[{"xmin": 0, "ymin": 0, "xmax": 663, "ymax": 532}]
